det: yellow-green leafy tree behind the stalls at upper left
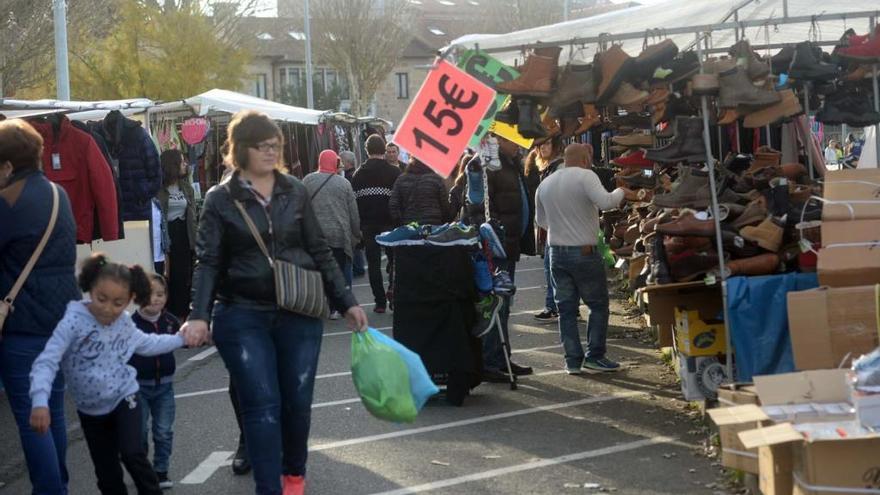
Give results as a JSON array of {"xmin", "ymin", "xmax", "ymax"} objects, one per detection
[{"xmin": 70, "ymin": 0, "xmax": 250, "ymax": 100}]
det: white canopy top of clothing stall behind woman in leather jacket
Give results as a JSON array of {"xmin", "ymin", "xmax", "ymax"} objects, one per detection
[{"xmin": 153, "ymin": 89, "xmax": 326, "ymax": 125}]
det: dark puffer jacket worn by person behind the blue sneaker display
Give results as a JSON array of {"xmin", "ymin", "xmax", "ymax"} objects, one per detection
[{"xmin": 388, "ymin": 162, "xmax": 452, "ymax": 226}]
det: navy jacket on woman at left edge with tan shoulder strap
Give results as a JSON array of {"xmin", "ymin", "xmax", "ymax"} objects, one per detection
[{"xmin": 0, "ymin": 170, "xmax": 82, "ymax": 337}]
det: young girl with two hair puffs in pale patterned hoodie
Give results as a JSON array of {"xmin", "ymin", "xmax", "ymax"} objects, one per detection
[{"xmin": 30, "ymin": 254, "xmax": 184, "ymax": 495}]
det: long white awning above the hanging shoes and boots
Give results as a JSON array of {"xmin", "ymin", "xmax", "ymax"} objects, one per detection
[{"xmin": 447, "ymin": 0, "xmax": 878, "ymax": 63}]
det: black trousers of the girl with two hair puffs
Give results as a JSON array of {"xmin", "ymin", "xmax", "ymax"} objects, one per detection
[{"xmin": 77, "ymin": 394, "xmax": 162, "ymax": 495}]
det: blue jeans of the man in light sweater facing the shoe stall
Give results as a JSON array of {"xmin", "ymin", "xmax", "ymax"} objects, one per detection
[{"xmin": 550, "ymin": 246, "xmax": 609, "ymax": 368}]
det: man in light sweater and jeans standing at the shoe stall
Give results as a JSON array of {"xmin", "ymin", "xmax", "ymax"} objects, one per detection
[{"xmin": 535, "ymin": 143, "xmax": 637, "ymax": 375}]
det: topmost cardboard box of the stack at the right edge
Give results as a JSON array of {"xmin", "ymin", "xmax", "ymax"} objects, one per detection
[{"xmin": 822, "ymin": 168, "xmax": 880, "ymax": 222}]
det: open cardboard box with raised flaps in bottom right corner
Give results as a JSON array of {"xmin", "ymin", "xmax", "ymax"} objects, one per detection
[{"xmin": 739, "ymin": 422, "xmax": 880, "ymax": 495}]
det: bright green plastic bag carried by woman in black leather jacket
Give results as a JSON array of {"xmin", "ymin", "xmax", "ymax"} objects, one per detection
[{"xmin": 351, "ymin": 332, "xmax": 418, "ymax": 423}]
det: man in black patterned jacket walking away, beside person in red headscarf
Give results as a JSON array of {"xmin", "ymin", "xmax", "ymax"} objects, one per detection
[{"xmin": 351, "ymin": 134, "xmax": 400, "ymax": 313}]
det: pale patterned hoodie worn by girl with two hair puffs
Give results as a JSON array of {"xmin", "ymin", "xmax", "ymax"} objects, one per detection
[{"xmin": 30, "ymin": 301, "xmax": 184, "ymax": 416}]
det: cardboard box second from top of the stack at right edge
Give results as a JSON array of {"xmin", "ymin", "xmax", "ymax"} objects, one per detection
[{"xmin": 816, "ymin": 220, "xmax": 880, "ymax": 287}]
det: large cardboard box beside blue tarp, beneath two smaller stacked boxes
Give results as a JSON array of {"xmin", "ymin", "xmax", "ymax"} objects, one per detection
[{"xmin": 788, "ymin": 284, "xmax": 880, "ymax": 370}]
